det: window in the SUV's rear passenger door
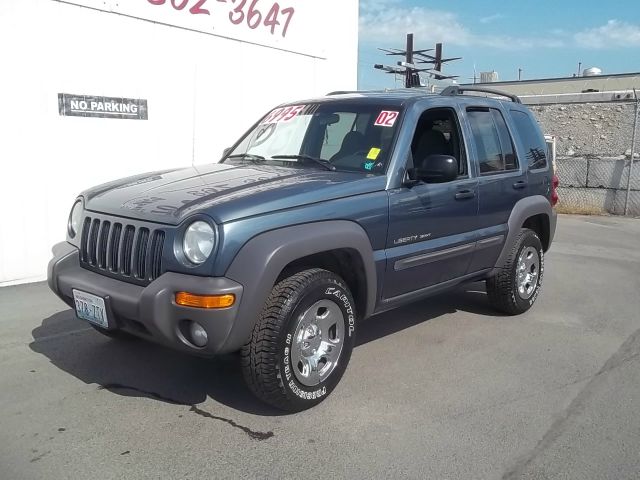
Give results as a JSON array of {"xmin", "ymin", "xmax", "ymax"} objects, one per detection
[{"xmin": 467, "ymin": 108, "xmax": 518, "ymax": 175}]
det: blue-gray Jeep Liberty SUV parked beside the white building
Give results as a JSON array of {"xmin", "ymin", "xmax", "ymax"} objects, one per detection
[{"xmin": 48, "ymin": 87, "xmax": 558, "ymax": 411}]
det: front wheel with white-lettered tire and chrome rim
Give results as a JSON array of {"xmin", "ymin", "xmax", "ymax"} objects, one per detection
[{"xmin": 241, "ymin": 268, "xmax": 356, "ymax": 412}]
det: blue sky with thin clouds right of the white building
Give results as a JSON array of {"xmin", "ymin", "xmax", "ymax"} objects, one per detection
[{"xmin": 358, "ymin": 0, "xmax": 640, "ymax": 89}]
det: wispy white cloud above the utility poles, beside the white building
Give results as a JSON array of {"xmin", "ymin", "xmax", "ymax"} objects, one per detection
[{"xmin": 360, "ymin": 0, "xmax": 564, "ymax": 50}]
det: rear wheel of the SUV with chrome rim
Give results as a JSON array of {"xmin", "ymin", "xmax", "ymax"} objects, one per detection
[{"xmin": 487, "ymin": 228, "xmax": 544, "ymax": 315}]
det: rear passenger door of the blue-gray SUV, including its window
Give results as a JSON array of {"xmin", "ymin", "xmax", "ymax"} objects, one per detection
[{"xmin": 465, "ymin": 103, "xmax": 529, "ymax": 272}]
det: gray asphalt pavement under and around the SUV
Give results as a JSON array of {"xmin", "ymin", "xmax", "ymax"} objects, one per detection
[{"xmin": 0, "ymin": 216, "xmax": 640, "ymax": 480}]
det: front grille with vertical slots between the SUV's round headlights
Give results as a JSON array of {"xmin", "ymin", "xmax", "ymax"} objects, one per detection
[{"xmin": 80, "ymin": 216, "xmax": 165, "ymax": 285}]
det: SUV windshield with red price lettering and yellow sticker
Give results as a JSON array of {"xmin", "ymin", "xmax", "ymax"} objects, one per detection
[{"xmin": 223, "ymin": 101, "xmax": 402, "ymax": 173}]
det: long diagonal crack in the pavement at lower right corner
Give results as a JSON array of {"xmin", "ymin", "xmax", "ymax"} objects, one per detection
[{"xmin": 502, "ymin": 329, "xmax": 640, "ymax": 480}]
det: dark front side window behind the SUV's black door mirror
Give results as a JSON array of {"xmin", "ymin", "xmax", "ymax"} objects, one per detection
[{"xmin": 411, "ymin": 108, "xmax": 469, "ymax": 178}]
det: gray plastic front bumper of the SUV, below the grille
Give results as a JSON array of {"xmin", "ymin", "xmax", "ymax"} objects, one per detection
[{"xmin": 47, "ymin": 242, "xmax": 243, "ymax": 356}]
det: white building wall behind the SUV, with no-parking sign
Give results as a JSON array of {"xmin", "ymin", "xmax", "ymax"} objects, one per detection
[{"xmin": 0, "ymin": 0, "xmax": 358, "ymax": 285}]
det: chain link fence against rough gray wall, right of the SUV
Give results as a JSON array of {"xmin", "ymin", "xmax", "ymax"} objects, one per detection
[{"xmin": 531, "ymin": 91, "xmax": 640, "ymax": 217}]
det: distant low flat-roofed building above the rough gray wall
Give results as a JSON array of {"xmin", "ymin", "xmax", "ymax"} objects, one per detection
[{"xmin": 465, "ymin": 67, "xmax": 640, "ymax": 95}]
